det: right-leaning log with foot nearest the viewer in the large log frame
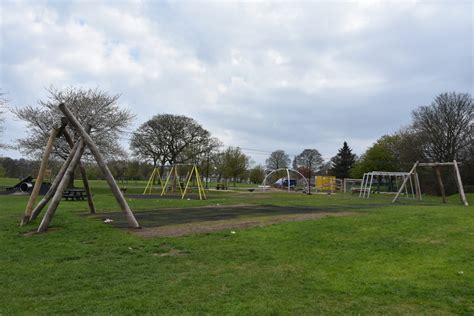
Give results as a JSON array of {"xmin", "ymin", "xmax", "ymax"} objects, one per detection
[{"xmin": 38, "ymin": 139, "xmax": 84, "ymax": 233}]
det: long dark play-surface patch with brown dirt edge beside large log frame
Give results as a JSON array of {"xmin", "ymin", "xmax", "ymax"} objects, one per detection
[{"xmin": 95, "ymin": 205, "xmax": 360, "ymax": 237}]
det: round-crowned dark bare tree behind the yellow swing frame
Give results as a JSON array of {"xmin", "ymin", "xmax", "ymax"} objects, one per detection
[{"xmin": 130, "ymin": 114, "xmax": 212, "ymax": 167}]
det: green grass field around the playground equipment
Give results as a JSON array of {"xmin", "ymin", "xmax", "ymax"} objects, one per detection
[{"xmin": 0, "ymin": 181, "xmax": 474, "ymax": 315}]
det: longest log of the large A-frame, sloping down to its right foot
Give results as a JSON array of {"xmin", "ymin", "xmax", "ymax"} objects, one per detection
[{"xmin": 59, "ymin": 103, "xmax": 140, "ymax": 228}]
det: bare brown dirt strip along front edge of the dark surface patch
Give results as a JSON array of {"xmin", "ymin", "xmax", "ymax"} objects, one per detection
[{"xmin": 129, "ymin": 212, "xmax": 355, "ymax": 237}]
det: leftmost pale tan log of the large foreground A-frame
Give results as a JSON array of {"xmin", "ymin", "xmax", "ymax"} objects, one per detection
[{"xmin": 20, "ymin": 122, "xmax": 66, "ymax": 226}]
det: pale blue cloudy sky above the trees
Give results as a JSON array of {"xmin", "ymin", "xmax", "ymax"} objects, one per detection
[{"xmin": 0, "ymin": 0, "xmax": 474, "ymax": 163}]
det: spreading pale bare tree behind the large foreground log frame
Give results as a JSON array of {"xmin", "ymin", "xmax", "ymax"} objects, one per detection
[{"xmin": 13, "ymin": 87, "xmax": 134, "ymax": 159}]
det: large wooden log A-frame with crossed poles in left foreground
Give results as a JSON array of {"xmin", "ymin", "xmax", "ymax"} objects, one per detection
[{"xmin": 21, "ymin": 103, "xmax": 140, "ymax": 233}]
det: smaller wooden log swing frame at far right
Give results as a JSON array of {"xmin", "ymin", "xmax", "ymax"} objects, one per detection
[{"xmin": 392, "ymin": 160, "xmax": 469, "ymax": 206}]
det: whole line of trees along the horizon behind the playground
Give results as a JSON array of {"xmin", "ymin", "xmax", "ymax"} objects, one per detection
[{"xmin": 0, "ymin": 87, "xmax": 474, "ymax": 190}]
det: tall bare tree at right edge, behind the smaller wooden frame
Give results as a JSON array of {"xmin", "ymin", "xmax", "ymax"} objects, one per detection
[{"xmin": 412, "ymin": 92, "xmax": 474, "ymax": 162}]
